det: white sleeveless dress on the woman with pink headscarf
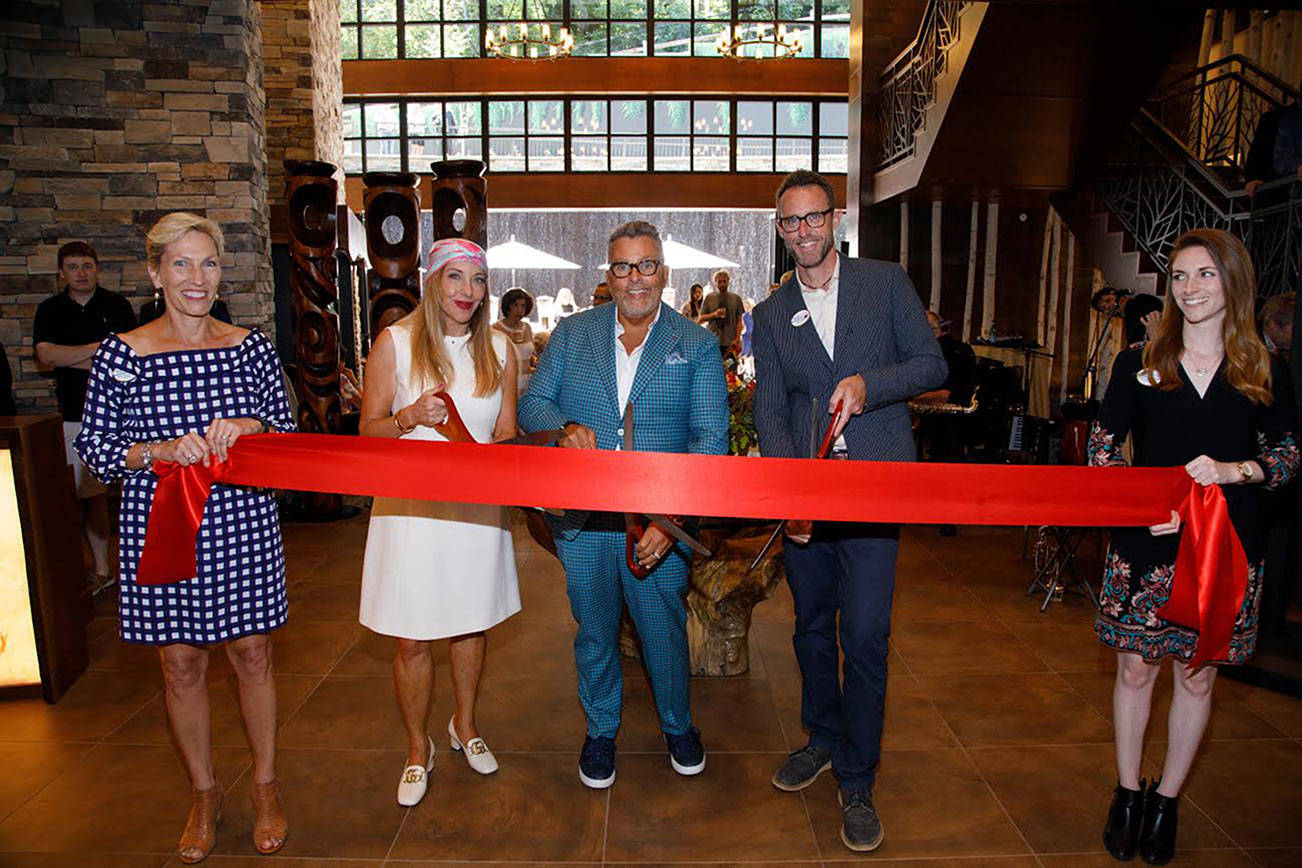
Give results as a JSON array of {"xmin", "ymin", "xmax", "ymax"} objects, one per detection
[{"xmin": 359, "ymin": 324, "xmax": 519, "ymax": 639}]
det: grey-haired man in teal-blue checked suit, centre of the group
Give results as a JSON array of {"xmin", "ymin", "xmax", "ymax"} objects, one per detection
[{"xmin": 518, "ymin": 220, "xmax": 728, "ymax": 789}]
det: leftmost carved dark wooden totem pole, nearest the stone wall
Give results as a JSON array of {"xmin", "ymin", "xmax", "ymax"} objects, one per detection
[{"xmin": 285, "ymin": 160, "xmax": 342, "ymax": 518}]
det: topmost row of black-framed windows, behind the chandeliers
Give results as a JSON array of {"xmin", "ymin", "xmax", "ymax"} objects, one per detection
[{"xmin": 340, "ymin": 0, "xmax": 850, "ymax": 60}]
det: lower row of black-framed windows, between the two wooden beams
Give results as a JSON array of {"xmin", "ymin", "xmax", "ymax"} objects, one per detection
[{"xmin": 344, "ymin": 96, "xmax": 849, "ymax": 174}]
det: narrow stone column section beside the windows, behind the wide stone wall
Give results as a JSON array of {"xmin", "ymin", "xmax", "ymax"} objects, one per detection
[{"xmin": 262, "ymin": 0, "xmax": 344, "ymax": 203}]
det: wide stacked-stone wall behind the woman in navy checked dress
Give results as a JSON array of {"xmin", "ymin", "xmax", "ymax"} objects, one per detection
[{"xmin": 0, "ymin": 0, "xmax": 275, "ymax": 411}]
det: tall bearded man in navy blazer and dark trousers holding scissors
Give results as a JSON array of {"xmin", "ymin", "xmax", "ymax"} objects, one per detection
[{"xmin": 754, "ymin": 170, "xmax": 947, "ymax": 851}]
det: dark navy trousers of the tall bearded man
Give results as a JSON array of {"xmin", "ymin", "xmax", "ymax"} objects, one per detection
[{"xmin": 783, "ymin": 522, "xmax": 900, "ymax": 790}]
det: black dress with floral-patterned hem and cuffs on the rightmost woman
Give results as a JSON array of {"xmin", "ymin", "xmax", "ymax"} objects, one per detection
[{"xmin": 1088, "ymin": 349, "xmax": 1299, "ymax": 664}]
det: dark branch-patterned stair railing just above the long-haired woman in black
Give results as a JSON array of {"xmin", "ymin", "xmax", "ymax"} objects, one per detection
[{"xmin": 1096, "ymin": 111, "xmax": 1302, "ymax": 298}]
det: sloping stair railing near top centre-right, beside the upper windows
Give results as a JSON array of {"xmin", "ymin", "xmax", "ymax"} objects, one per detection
[{"xmin": 878, "ymin": 0, "xmax": 970, "ymax": 169}]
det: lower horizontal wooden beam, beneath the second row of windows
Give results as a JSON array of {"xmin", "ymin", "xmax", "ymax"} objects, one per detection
[{"xmin": 346, "ymin": 172, "xmax": 845, "ymax": 211}]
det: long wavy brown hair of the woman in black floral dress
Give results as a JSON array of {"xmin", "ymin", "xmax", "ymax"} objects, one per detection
[{"xmin": 1143, "ymin": 229, "xmax": 1272, "ymax": 406}]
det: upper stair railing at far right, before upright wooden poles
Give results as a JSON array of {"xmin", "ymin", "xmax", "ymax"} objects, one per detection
[{"xmin": 1148, "ymin": 55, "xmax": 1298, "ymax": 178}]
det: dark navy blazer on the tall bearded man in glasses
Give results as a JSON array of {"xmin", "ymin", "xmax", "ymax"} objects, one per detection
[{"xmin": 754, "ymin": 256, "xmax": 948, "ymax": 461}]
